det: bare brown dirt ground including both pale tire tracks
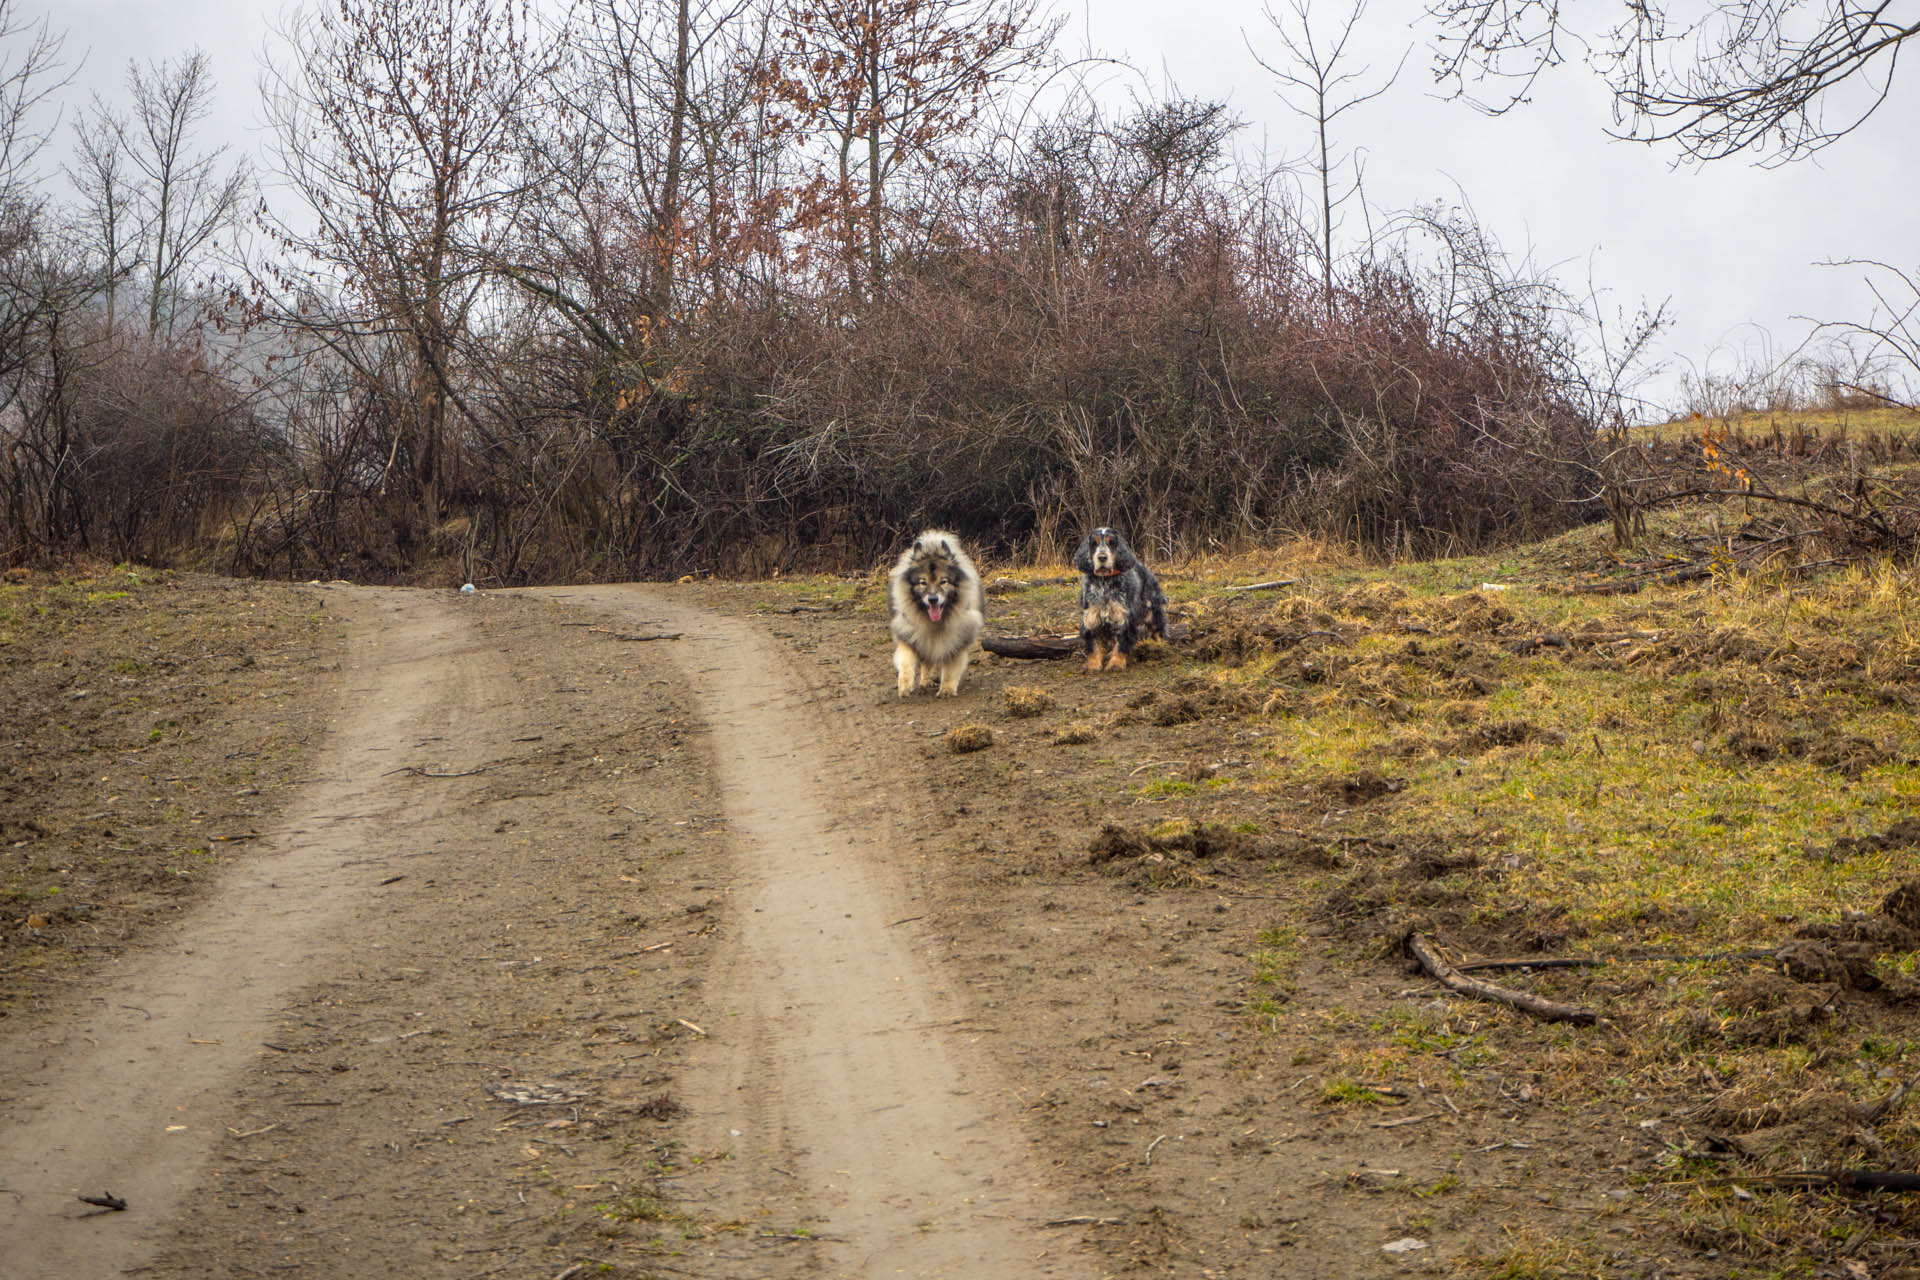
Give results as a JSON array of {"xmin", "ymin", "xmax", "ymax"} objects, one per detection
[{"xmin": 0, "ymin": 578, "xmax": 1882, "ymax": 1280}]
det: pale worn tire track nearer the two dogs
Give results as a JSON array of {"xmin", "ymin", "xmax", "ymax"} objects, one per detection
[{"xmin": 553, "ymin": 587, "xmax": 1079, "ymax": 1278}]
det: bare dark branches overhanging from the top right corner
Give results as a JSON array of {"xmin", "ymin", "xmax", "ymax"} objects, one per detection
[{"xmin": 1428, "ymin": 0, "xmax": 1920, "ymax": 163}]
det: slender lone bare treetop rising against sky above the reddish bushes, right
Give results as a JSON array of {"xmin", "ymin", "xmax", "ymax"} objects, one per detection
[{"xmin": 1248, "ymin": 0, "xmax": 1405, "ymax": 317}]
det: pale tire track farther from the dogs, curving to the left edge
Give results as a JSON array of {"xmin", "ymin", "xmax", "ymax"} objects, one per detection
[{"xmin": 0, "ymin": 591, "xmax": 499, "ymax": 1280}]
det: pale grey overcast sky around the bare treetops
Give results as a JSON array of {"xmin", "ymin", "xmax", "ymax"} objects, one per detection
[{"xmin": 23, "ymin": 0, "xmax": 1920, "ymax": 410}]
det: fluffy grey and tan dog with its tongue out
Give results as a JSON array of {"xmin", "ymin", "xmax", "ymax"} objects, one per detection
[{"xmin": 887, "ymin": 530, "xmax": 987, "ymax": 699}]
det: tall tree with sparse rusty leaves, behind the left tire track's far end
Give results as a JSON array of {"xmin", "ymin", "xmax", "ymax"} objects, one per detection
[{"xmin": 263, "ymin": 0, "xmax": 551, "ymax": 520}]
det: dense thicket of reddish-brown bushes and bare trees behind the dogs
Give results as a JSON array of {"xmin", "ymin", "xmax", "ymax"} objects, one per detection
[{"xmin": 0, "ymin": 0, "xmax": 1619, "ymax": 583}]
